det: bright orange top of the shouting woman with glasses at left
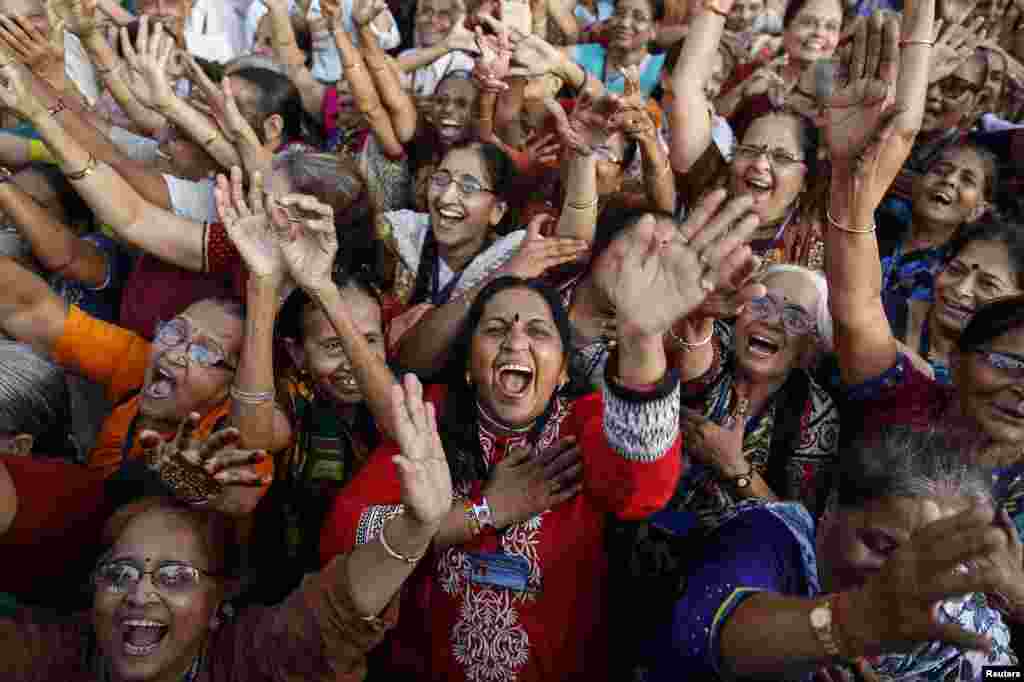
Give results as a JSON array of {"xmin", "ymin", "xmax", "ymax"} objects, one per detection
[{"xmin": 53, "ymin": 305, "xmax": 273, "ymax": 483}]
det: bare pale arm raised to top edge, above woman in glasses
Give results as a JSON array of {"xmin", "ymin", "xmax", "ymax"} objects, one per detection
[{"xmin": 669, "ymin": 0, "xmax": 738, "ymax": 173}]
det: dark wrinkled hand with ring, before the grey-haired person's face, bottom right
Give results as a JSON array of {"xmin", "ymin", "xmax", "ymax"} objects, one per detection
[{"xmin": 843, "ymin": 503, "xmax": 1013, "ymax": 656}]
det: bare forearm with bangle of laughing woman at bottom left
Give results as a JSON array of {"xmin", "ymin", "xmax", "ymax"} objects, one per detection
[{"xmin": 346, "ymin": 514, "xmax": 437, "ymax": 615}]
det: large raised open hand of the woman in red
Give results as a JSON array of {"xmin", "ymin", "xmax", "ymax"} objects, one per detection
[{"xmin": 597, "ymin": 189, "xmax": 758, "ymax": 338}]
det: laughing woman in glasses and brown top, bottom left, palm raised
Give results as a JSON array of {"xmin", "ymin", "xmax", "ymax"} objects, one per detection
[{"xmin": 0, "ymin": 378, "xmax": 452, "ymax": 682}]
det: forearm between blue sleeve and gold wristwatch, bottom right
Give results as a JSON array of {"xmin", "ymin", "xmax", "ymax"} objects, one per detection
[{"xmin": 712, "ymin": 592, "xmax": 835, "ymax": 678}]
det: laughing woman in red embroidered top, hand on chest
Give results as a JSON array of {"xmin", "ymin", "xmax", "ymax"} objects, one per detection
[{"xmin": 321, "ymin": 193, "xmax": 756, "ymax": 682}]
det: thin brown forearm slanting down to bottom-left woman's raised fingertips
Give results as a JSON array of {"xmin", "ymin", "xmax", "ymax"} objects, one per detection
[{"xmin": 309, "ymin": 283, "xmax": 397, "ymax": 438}]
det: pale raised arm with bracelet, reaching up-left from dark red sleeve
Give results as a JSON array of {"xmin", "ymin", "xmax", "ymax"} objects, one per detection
[{"xmin": 0, "ymin": 65, "xmax": 204, "ymax": 271}]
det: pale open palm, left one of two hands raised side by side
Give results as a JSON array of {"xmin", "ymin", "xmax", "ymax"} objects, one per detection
[{"xmin": 214, "ymin": 166, "xmax": 288, "ymax": 281}]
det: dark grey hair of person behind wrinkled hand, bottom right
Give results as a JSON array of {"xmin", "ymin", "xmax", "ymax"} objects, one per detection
[{"xmin": 829, "ymin": 425, "xmax": 992, "ymax": 508}]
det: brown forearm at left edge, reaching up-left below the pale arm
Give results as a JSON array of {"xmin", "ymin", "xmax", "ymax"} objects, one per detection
[{"xmin": 0, "ymin": 182, "xmax": 106, "ymax": 288}]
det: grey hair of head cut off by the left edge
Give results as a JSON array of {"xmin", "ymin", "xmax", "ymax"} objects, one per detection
[{"xmin": 0, "ymin": 339, "xmax": 68, "ymax": 436}]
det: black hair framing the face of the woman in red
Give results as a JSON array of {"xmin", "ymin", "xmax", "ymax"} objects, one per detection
[{"xmin": 437, "ymin": 276, "xmax": 574, "ymax": 484}]
